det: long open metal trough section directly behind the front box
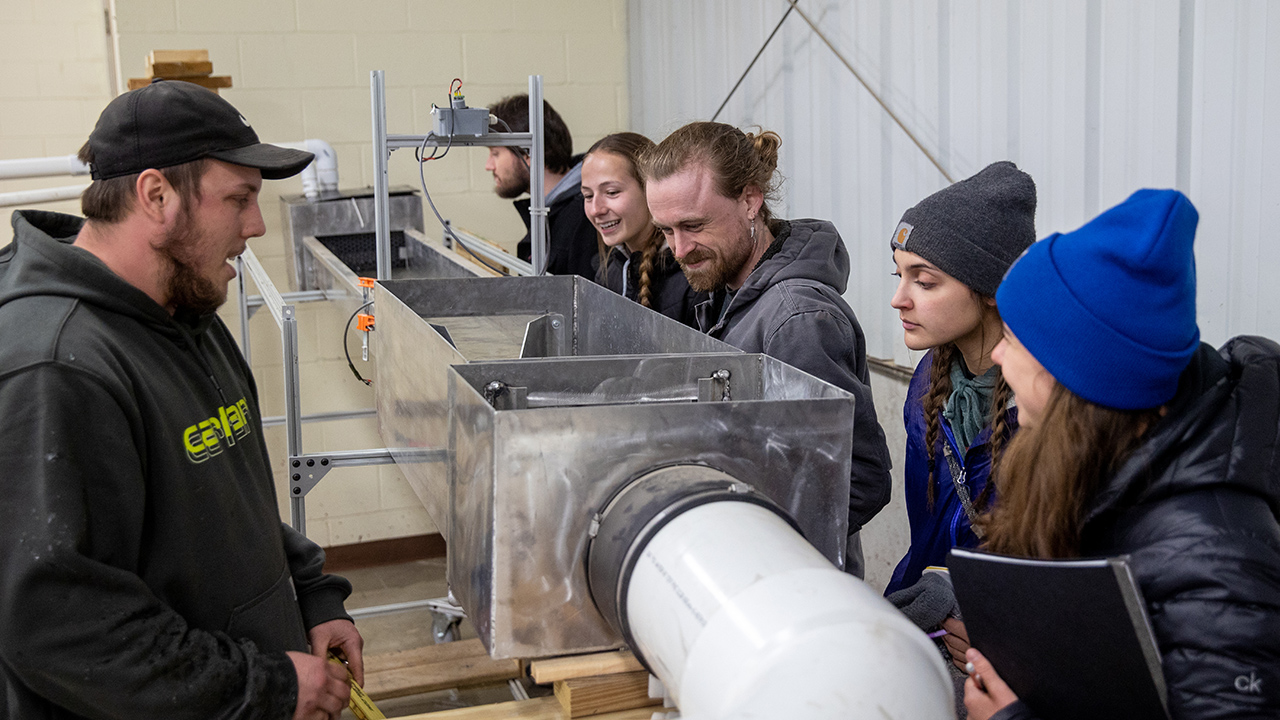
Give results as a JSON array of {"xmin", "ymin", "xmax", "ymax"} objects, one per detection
[{"xmin": 372, "ymin": 277, "xmax": 737, "ymax": 538}]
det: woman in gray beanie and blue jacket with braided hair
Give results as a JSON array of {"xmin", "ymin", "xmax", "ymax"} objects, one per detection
[{"xmin": 884, "ymin": 161, "xmax": 1036, "ymax": 671}]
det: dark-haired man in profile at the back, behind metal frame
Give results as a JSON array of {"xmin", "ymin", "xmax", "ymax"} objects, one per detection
[{"xmin": 484, "ymin": 94, "xmax": 598, "ymax": 279}]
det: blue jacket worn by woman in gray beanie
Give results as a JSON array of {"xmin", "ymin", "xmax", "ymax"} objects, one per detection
[{"xmin": 884, "ymin": 351, "xmax": 1018, "ymax": 594}]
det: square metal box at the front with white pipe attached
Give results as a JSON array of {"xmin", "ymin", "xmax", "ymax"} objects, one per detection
[{"xmin": 448, "ymin": 354, "xmax": 854, "ymax": 657}]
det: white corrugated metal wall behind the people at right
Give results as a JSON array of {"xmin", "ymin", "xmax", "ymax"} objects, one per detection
[{"xmin": 628, "ymin": 0, "xmax": 1280, "ymax": 365}]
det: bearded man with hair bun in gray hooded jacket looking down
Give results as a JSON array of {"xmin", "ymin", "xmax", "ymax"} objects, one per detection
[{"xmin": 640, "ymin": 122, "xmax": 890, "ymax": 578}]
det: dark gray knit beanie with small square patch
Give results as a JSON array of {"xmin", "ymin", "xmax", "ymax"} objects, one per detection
[{"xmin": 890, "ymin": 160, "xmax": 1036, "ymax": 297}]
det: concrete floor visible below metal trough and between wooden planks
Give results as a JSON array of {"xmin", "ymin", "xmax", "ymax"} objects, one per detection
[{"xmin": 339, "ymin": 557, "xmax": 524, "ymax": 720}]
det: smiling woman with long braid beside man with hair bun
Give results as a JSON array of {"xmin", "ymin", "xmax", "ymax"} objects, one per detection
[{"xmin": 582, "ymin": 132, "xmax": 707, "ymax": 327}]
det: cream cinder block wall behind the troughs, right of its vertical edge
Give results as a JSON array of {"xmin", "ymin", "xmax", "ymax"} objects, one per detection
[{"xmin": 116, "ymin": 0, "xmax": 627, "ymax": 546}]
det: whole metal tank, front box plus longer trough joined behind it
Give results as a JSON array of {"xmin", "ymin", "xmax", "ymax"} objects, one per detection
[{"xmin": 375, "ymin": 277, "xmax": 854, "ymax": 659}]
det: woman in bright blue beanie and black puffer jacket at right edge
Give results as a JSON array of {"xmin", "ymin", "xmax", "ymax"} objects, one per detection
[{"xmin": 965, "ymin": 190, "xmax": 1280, "ymax": 720}]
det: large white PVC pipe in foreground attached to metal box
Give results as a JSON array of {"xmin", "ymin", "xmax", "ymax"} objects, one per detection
[{"xmin": 626, "ymin": 502, "xmax": 955, "ymax": 720}]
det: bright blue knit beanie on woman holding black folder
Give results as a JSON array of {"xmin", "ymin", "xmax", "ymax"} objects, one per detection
[{"xmin": 996, "ymin": 190, "xmax": 1199, "ymax": 410}]
